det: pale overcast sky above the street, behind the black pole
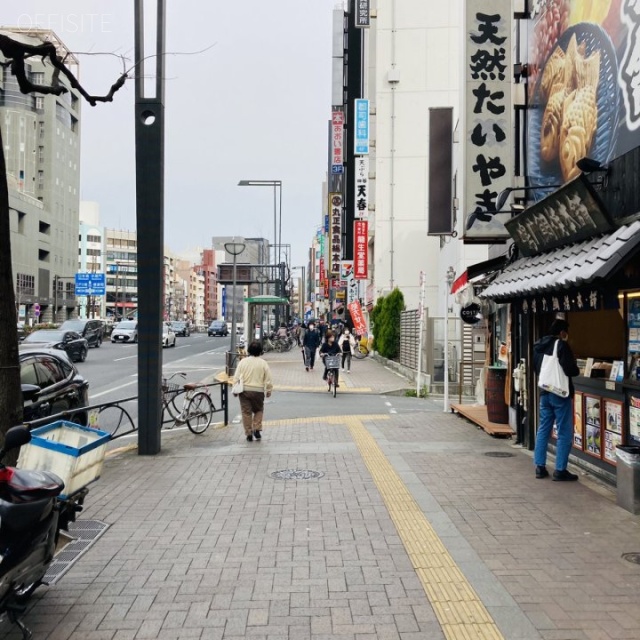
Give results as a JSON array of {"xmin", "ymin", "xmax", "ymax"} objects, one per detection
[{"xmin": 5, "ymin": 0, "xmax": 337, "ymax": 265}]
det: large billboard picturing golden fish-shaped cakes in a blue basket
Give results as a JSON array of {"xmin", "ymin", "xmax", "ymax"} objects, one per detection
[{"xmin": 527, "ymin": 0, "xmax": 640, "ymax": 195}]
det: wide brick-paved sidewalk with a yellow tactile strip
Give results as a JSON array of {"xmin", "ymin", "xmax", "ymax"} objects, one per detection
[{"xmin": 5, "ymin": 352, "xmax": 640, "ymax": 640}]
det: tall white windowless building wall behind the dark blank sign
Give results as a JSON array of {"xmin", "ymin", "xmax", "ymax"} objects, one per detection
[{"xmin": 363, "ymin": 0, "xmax": 487, "ymax": 316}]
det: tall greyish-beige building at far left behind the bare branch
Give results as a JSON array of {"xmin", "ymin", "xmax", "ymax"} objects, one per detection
[{"xmin": 0, "ymin": 28, "xmax": 81, "ymax": 321}]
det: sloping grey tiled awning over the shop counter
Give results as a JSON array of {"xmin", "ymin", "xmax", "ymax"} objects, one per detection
[{"xmin": 480, "ymin": 221, "xmax": 640, "ymax": 302}]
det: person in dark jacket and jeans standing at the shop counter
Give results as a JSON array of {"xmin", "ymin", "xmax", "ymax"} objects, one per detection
[{"xmin": 533, "ymin": 318, "xmax": 580, "ymax": 481}]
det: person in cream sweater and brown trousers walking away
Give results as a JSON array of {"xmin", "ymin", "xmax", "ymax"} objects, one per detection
[{"xmin": 235, "ymin": 340, "xmax": 273, "ymax": 442}]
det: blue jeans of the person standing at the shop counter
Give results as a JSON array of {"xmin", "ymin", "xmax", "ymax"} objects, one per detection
[{"xmin": 533, "ymin": 393, "xmax": 573, "ymax": 471}]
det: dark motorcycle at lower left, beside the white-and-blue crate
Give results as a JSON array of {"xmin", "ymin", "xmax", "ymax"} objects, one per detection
[{"xmin": 0, "ymin": 426, "xmax": 88, "ymax": 640}]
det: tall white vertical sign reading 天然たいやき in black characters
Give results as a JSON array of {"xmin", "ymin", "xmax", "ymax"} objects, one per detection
[{"xmin": 464, "ymin": 0, "xmax": 513, "ymax": 242}]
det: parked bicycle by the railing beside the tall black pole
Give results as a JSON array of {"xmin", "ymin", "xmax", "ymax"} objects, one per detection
[{"xmin": 162, "ymin": 372, "xmax": 216, "ymax": 434}]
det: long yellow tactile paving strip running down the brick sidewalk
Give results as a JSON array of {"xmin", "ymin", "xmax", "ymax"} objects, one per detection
[{"xmin": 343, "ymin": 417, "xmax": 504, "ymax": 640}]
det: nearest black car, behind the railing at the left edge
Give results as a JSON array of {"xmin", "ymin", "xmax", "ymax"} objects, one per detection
[{"xmin": 20, "ymin": 347, "xmax": 89, "ymax": 424}]
